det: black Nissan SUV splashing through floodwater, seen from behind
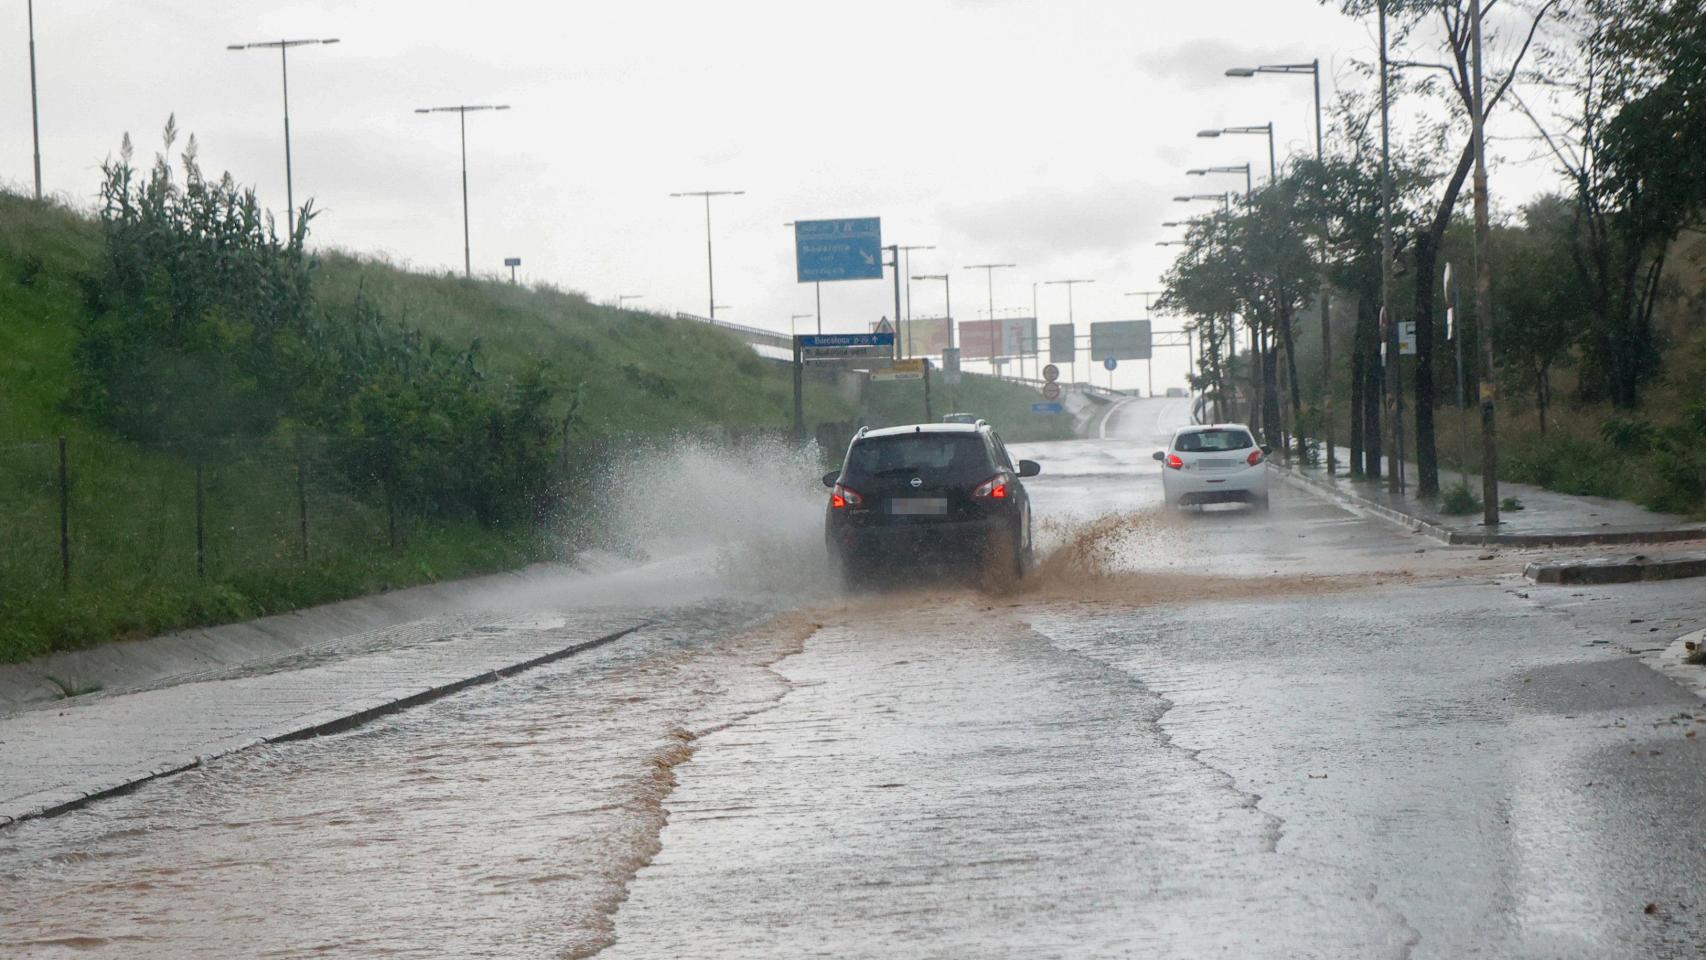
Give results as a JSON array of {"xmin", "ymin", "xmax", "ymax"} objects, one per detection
[{"xmin": 824, "ymin": 421, "xmax": 1042, "ymax": 583}]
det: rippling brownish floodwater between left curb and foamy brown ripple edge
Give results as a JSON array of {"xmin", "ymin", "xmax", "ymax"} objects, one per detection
[{"xmin": 0, "ymin": 610, "xmax": 809, "ymax": 958}]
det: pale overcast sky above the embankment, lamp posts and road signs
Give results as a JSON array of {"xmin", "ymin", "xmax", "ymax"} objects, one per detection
[{"xmin": 0, "ymin": 0, "xmax": 1569, "ymax": 387}]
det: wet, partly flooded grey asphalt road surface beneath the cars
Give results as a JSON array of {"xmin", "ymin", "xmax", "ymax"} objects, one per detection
[{"xmin": 0, "ymin": 401, "xmax": 1706, "ymax": 960}]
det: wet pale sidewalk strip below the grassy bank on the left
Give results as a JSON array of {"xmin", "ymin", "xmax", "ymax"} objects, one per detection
[{"xmin": 0, "ymin": 616, "xmax": 645, "ymax": 827}]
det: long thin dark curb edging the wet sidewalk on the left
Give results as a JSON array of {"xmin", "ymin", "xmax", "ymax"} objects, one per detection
[{"xmin": 0, "ymin": 622, "xmax": 650, "ymax": 830}]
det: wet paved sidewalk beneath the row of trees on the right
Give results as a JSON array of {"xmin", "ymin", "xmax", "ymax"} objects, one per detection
[{"xmin": 1274, "ymin": 460, "xmax": 1706, "ymax": 547}]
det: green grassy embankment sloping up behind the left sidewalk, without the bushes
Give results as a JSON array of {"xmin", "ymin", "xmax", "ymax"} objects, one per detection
[{"xmin": 0, "ymin": 193, "xmax": 1057, "ymax": 662}]
